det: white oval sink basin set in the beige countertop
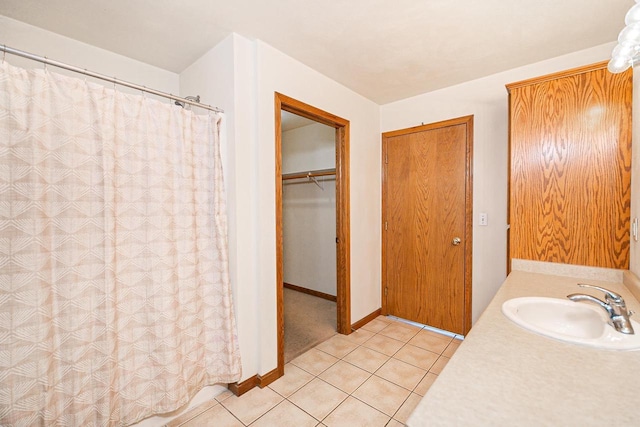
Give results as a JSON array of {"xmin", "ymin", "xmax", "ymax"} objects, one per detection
[{"xmin": 502, "ymin": 297, "xmax": 640, "ymax": 350}]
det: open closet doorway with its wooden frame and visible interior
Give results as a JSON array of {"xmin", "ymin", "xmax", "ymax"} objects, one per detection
[{"xmin": 275, "ymin": 93, "xmax": 351, "ymax": 376}]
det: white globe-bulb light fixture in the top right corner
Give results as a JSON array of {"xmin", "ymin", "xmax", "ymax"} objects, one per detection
[{"xmin": 607, "ymin": 0, "xmax": 640, "ymax": 73}]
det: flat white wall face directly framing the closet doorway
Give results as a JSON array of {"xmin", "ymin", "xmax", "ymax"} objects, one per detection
[{"xmin": 255, "ymin": 41, "xmax": 380, "ymax": 373}]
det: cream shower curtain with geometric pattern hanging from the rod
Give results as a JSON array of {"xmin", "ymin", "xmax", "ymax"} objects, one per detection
[{"xmin": 0, "ymin": 63, "xmax": 240, "ymax": 426}]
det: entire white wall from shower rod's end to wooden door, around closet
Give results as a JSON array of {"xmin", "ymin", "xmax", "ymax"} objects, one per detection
[{"xmin": 180, "ymin": 34, "xmax": 380, "ymax": 381}]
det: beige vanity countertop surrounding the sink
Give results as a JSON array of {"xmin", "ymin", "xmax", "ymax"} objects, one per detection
[{"xmin": 407, "ymin": 271, "xmax": 640, "ymax": 427}]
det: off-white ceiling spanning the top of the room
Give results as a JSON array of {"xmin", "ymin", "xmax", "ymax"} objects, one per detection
[{"xmin": 0, "ymin": 0, "xmax": 634, "ymax": 104}]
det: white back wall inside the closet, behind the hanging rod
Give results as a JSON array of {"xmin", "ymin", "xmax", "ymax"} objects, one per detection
[{"xmin": 282, "ymin": 123, "xmax": 336, "ymax": 296}]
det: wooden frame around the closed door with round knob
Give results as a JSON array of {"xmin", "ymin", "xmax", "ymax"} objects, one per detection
[{"xmin": 381, "ymin": 115, "xmax": 473, "ymax": 335}]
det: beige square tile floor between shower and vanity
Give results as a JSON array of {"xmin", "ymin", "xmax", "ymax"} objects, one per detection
[{"xmin": 168, "ymin": 316, "xmax": 461, "ymax": 427}]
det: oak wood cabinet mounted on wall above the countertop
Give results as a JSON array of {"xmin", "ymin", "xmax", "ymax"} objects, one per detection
[{"xmin": 507, "ymin": 62, "xmax": 633, "ymax": 269}]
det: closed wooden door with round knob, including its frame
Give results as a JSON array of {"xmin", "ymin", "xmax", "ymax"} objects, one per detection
[{"xmin": 383, "ymin": 116, "xmax": 473, "ymax": 334}]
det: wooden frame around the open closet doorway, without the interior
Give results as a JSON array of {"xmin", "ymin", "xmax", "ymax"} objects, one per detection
[{"xmin": 275, "ymin": 92, "xmax": 351, "ymax": 376}]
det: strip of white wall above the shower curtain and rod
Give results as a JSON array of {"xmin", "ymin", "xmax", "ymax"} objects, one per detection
[{"xmin": 0, "ymin": 15, "xmax": 179, "ymax": 96}]
